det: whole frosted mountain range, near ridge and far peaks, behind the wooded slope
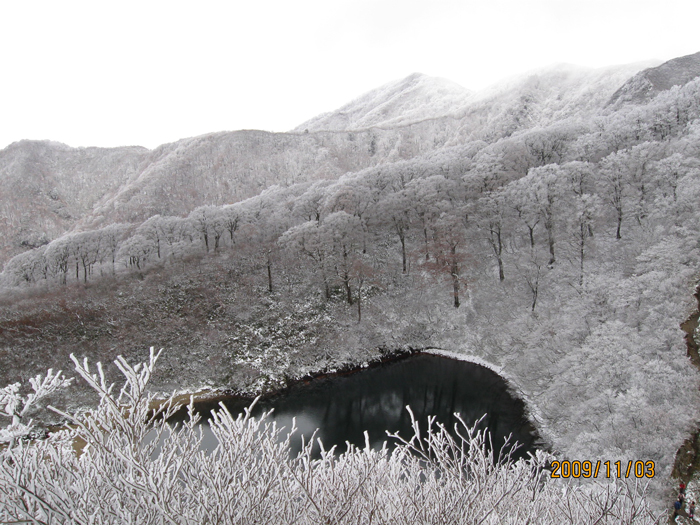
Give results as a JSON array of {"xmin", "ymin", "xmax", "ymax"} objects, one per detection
[{"xmin": 0, "ymin": 59, "xmax": 680, "ymax": 262}]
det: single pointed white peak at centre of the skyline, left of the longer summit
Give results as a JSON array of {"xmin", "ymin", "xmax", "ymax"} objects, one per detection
[{"xmin": 294, "ymin": 73, "xmax": 473, "ymax": 131}]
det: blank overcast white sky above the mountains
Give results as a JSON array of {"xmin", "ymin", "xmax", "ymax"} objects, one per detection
[{"xmin": 0, "ymin": 0, "xmax": 700, "ymax": 148}]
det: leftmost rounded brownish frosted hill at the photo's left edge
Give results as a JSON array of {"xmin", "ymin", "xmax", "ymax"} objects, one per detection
[{"xmin": 0, "ymin": 140, "xmax": 150, "ymax": 261}]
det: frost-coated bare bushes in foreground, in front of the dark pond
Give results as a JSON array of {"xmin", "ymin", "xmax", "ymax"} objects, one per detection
[{"xmin": 0, "ymin": 351, "xmax": 660, "ymax": 524}]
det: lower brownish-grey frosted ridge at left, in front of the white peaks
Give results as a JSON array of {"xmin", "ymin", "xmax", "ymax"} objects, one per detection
[{"xmin": 0, "ymin": 125, "xmax": 434, "ymax": 265}]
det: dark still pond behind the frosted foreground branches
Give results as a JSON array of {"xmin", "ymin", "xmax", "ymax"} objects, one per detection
[{"xmin": 186, "ymin": 354, "xmax": 538, "ymax": 457}]
